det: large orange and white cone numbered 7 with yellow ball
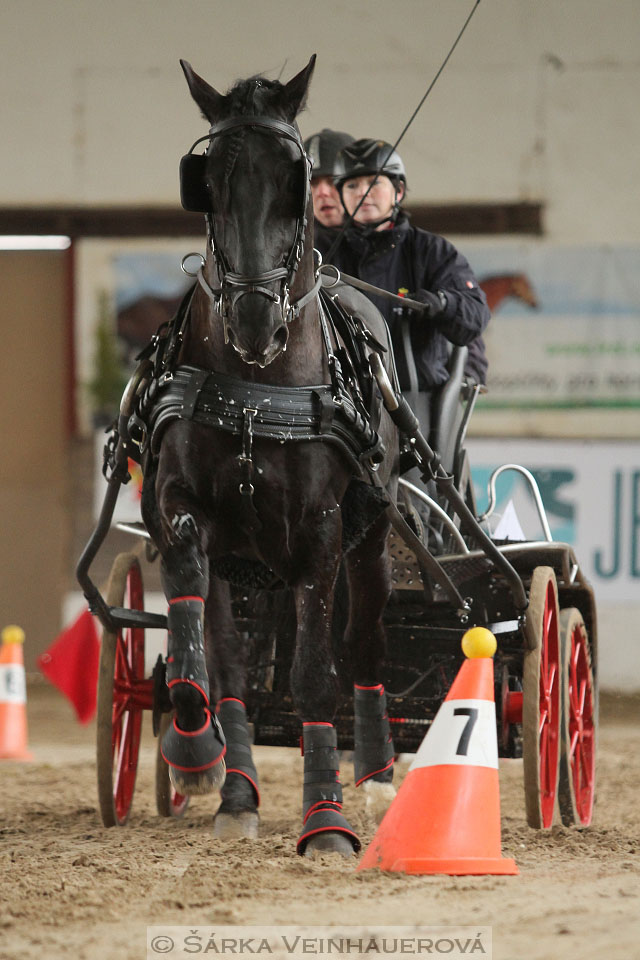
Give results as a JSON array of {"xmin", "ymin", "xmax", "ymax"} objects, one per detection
[{"xmin": 358, "ymin": 627, "xmax": 518, "ymax": 875}]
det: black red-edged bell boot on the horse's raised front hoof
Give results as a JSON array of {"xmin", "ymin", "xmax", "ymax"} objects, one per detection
[{"xmin": 161, "ymin": 709, "xmax": 226, "ymax": 795}]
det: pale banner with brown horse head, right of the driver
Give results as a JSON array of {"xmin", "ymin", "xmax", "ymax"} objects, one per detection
[{"xmin": 462, "ymin": 240, "xmax": 640, "ymax": 410}]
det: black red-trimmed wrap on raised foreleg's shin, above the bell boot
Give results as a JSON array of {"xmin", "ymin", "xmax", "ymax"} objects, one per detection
[{"xmin": 167, "ymin": 597, "xmax": 209, "ymax": 704}]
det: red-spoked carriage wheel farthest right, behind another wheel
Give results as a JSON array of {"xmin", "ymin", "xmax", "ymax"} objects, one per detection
[{"xmin": 558, "ymin": 607, "xmax": 596, "ymax": 827}]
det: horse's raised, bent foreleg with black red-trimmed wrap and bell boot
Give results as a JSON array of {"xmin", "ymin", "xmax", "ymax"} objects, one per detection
[{"xmin": 162, "ymin": 511, "xmax": 225, "ymax": 794}]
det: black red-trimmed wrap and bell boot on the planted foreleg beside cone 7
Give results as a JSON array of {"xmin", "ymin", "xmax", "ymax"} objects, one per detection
[{"xmin": 297, "ymin": 723, "xmax": 360, "ymax": 856}]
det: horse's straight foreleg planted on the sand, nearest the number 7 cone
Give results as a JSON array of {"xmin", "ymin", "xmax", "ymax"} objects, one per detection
[{"xmin": 291, "ymin": 546, "xmax": 360, "ymax": 856}]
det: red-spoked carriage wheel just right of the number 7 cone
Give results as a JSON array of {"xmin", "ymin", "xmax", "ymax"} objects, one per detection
[{"xmin": 522, "ymin": 567, "xmax": 561, "ymax": 829}]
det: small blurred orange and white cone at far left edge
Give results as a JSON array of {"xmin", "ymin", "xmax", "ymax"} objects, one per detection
[{"xmin": 0, "ymin": 626, "xmax": 32, "ymax": 760}]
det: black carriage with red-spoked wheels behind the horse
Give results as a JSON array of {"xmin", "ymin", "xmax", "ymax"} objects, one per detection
[{"xmin": 79, "ymin": 330, "xmax": 598, "ymax": 828}]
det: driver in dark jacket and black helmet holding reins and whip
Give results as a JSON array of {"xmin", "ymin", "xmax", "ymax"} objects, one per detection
[{"xmin": 316, "ymin": 139, "xmax": 489, "ymax": 398}]
